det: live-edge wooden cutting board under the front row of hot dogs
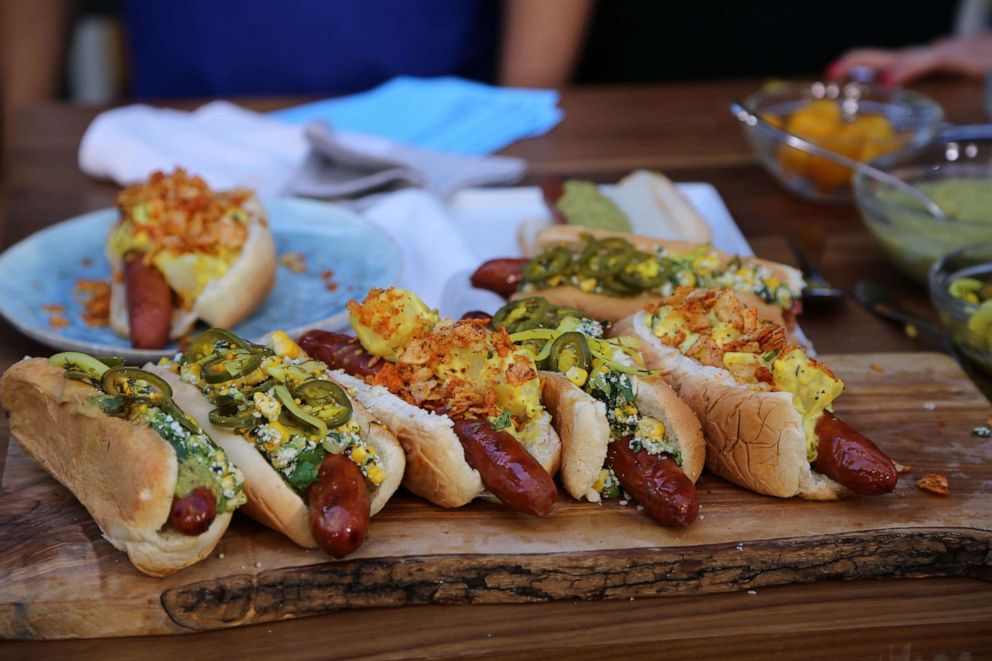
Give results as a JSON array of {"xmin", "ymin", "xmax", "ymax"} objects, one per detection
[{"xmin": 0, "ymin": 353, "xmax": 992, "ymax": 639}]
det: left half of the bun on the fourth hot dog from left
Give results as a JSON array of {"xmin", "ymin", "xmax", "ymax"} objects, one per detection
[{"xmin": 541, "ymin": 372, "xmax": 610, "ymax": 503}]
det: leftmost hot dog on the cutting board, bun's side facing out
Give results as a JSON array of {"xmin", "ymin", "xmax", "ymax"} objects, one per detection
[{"xmin": 2, "ymin": 352, "xmax": 245, "ymax": 576}]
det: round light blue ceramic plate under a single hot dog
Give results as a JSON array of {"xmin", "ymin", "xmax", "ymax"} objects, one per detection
[{"xmin": 0, "ymin": 198, "xmax": 402, "ymax": 362}]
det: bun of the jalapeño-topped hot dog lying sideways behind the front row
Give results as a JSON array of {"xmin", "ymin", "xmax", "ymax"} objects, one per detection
[{"xmin": 510, "ymin": 225, "xmax": 804, "ymax": 325}]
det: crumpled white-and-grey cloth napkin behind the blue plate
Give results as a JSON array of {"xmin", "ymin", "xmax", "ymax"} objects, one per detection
[{"xmin": 79, "ymin": 101, "xmax": 526, "ymax": 198}]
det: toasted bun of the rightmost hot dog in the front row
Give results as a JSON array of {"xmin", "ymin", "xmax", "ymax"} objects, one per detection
[{"xmin": 611, "ymin": 312, "xmax": 847, "ymax": 500}]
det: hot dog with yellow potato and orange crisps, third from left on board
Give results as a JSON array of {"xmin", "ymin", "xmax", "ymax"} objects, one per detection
[{"xmin": 300, "ymin": 289, "xmax": 561, "ymax": 515}]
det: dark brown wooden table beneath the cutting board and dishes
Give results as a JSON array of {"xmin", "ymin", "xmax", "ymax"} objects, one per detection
[{"xmin": 0, "ymin": 81, "xmax": 992, "ymax": 659}]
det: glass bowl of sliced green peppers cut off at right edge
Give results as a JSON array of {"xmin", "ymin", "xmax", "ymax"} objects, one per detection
[{"xmin": 930, "ymin": 242, "xmax": 992, "ymax": 372}]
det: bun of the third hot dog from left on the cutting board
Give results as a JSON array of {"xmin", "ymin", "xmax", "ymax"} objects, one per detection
[{"xmin": 331, "ymin": 370, "xmax": 561, "ymax": 507}]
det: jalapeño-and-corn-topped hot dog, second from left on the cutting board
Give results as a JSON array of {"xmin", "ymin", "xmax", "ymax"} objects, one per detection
[{"xmin": 148, "ymin": 329, "xmax": 405, "ymax": 558}]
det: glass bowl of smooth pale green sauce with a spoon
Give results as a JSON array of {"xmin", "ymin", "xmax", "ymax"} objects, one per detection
[{"xmin": 854, "ymin": 126, "xmax": 992, "ymax": 284}]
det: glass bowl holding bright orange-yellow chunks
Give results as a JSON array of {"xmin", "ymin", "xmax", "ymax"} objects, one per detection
[{"xmin": 742, "ymin": 82, "xmax": 944, "ymax": 202}]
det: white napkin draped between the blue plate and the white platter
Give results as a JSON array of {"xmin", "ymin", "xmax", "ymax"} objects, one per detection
[{"xmin": 363, "ymin": 189, "xmax": 478, "ymax": 312}]
